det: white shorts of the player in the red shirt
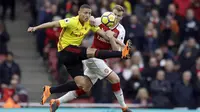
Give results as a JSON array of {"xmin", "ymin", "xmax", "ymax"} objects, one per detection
[{"xmin": 83, "ymin": 58, "xmax": 112, "ymax": 84}]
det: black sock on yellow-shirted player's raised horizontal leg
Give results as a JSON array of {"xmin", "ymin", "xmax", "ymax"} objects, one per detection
[{"xmin": 95, "ymin": 50, "xmax": 122, "ymax": 59}]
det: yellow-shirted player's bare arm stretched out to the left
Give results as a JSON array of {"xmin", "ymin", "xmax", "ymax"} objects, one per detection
[{"xmin": 27, "ymin": 21, "xmax": 60, "ymax": 32}]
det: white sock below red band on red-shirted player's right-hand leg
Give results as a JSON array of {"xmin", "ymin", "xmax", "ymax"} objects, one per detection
[{"xmin": 114, "ymin": 89, "xmax": 126, "ymax": 108}]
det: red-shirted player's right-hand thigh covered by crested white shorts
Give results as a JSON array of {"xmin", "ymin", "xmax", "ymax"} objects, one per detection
[{"xmin": 86, "ymin": 58, "xmax": 112, "ymax": 80}]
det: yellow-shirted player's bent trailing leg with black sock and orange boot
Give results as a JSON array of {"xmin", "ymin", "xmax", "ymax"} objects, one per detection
[{"xmin": 41, "ymin": 49, "xmax": 87, "ymax": 104}]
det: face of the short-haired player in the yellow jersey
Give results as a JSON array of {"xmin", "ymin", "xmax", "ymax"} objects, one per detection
[{"xmin": 78, "ymin": 8, "xmax": 92, "ymax": 22}]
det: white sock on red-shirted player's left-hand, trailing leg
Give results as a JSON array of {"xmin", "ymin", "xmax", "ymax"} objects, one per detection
[{"xmin": 58, "ymin": 91, "xmax": 77, "ymax": 104}]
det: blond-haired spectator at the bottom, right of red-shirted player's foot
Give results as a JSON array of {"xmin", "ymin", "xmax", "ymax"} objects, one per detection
[{"xmin": 133, "ymin": 88, "xmax": 152, "ymax": 107}]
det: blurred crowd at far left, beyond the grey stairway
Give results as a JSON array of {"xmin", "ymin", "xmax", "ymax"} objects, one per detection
[{"xmin": 0, "ymin": 0, "xmax": 28, "ymax": 108}]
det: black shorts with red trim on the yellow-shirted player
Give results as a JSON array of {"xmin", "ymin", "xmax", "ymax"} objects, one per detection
[{"xmin": 59, "ymin": 45, "xmax": 87, "ymax": 78}]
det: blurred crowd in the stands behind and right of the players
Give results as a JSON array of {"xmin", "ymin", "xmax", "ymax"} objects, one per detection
[{"xmin": 26, "ymin": 0, "xmax": 200, "ymax": 108}]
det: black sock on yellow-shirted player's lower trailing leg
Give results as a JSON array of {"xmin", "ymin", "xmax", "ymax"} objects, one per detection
[{"xmin": 50, "ymin": 81, "xmax": 78, "ymax": 94}]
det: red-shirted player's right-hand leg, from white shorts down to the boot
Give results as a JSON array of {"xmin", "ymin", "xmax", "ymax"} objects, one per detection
[{"xmin": 86, "ymin": 58, "xmax": 131, "ymax": 112}]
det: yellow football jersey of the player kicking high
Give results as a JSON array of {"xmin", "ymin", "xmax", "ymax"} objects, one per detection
[{"xmin": 57, "ymin": 16, "xmax": 100, "ymax": 51}]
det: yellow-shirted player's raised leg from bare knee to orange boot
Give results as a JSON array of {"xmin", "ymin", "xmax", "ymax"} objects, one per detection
[{"xmin": 87, "ymin": 40, "xmax": 131, "ymax": 59}]
